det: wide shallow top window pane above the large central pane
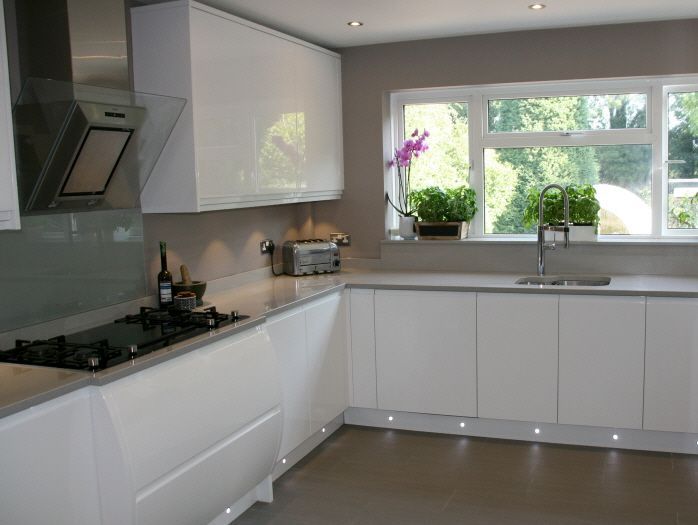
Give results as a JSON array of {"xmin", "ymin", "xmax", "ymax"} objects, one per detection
[{"xmin": 487, "ymin": 93, "xmax": 647, "ymax": 133}]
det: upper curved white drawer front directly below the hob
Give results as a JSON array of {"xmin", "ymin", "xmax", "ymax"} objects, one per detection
[{"xmin": 97, "ymin": 328, "xmax": 281, "ymax": 490}]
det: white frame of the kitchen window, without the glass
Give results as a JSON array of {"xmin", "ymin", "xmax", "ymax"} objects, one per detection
[{"xmin": 384, "ymin": 75, "xmax": 698, "ymax": 241}]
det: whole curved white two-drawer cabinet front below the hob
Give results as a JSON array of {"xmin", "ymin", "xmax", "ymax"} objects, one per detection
[{"xmin": 96, "ymin": 327, "xmax": 282, "ymax": 525}]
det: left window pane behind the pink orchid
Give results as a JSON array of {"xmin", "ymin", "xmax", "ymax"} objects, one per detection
[{"xmin": 404, "ymin": 102, "xmax": 470, "ymax": 190}]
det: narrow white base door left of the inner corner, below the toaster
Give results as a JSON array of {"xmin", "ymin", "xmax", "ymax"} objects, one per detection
[{"xmin": 305, "ymin": 293, "xmax": 349, "ymax": 433}]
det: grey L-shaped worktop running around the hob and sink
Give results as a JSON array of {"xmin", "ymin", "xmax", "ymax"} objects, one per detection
[{"xmin": 0, "ymin": 269, "xmax": 698, "ymax": 417}]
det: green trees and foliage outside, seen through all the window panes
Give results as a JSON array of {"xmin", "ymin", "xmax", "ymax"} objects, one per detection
[{"xmin": 405, "ymin": 93, "xmax": 698, "ymax": 234}]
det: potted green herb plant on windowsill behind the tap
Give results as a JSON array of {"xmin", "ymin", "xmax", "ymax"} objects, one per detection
[{"xmin": 523, "ymin": 184, "xmax": 601, "ymax": 241}]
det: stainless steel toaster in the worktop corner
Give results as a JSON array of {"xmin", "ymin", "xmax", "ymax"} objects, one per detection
[{"xmin": 282, "ymin": 239, "xmax": 342, "ymax": 275}]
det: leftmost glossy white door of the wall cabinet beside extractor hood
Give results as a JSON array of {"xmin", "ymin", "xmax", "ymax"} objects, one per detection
[{"xmin": 189, "ymin": 9, "xmax": 256, "ymax": 204}]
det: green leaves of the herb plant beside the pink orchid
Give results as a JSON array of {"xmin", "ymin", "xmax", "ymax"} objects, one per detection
[{"xmin": 412, "ymin": 186, "xmax": 477, "ymax": 222}]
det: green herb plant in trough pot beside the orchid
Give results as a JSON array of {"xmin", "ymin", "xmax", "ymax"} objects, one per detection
[{"xmin": 411, "ymin": 186, "xmax": 477, "ymax": 240}]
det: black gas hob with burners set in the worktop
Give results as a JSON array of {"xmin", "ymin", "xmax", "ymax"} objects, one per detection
[{"xmin": 0, "ymin": 307, "xmax": 249, "ymax": 372}]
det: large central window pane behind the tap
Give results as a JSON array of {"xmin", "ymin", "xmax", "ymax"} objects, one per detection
[{"xmin": 484, "ymin": 144, "xmax": 652, "ymax": 234}]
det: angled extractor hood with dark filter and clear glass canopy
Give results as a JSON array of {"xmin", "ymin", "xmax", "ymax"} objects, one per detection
[{"xmin": 14, "ymin": 79, "xmax": 185, "ymax": 215}]
